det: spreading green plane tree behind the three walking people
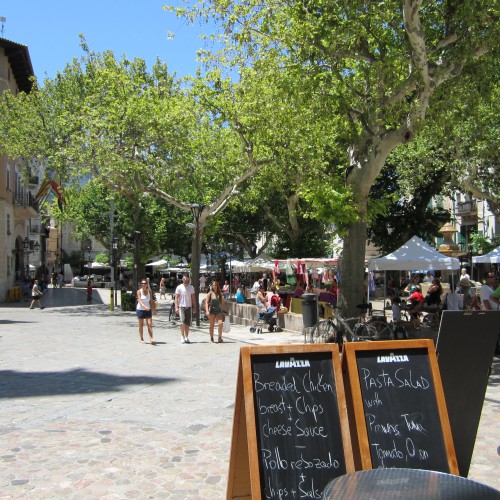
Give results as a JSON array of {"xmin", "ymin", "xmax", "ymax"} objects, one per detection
[{"xmin": 0, "ymin": 42, "xmax": 273, "ymax": 296}]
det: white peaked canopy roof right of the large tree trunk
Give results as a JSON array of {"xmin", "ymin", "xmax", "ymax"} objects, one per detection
[{"xmin": 368, "ymin": 236, "xmax": 460, "ymax": 271}]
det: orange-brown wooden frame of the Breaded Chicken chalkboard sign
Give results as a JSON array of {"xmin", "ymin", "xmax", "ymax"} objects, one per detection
[{"xmin": 227, "ymin": 344, "xmax": 354, "ymax": 499}]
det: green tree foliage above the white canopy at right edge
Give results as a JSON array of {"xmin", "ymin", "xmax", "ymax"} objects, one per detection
[{"xmin": 368, "ymin": 62, "xmax": 500, "ymax": 253}]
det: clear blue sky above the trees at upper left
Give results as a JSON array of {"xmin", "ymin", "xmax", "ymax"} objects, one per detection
[{"xmin": 0, "ymin": 0, "xmax": 209, "ymax": 82}]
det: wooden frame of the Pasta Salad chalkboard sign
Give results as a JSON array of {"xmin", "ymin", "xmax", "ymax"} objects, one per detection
[{"xmin": 342, "ymin": 339, "xmax": 458, "ymax": 475}]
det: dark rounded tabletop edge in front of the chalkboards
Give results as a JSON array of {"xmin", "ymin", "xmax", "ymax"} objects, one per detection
[{"xmin": 323, "ymin": 469, "xmax": 500, "ymax": 500}]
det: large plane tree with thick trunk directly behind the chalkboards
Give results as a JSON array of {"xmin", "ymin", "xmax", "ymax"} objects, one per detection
[{"xmin": 168, "ymin": 0, "xmax": 500, "ymax": 311}]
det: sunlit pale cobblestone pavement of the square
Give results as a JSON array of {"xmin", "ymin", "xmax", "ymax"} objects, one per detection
[{"xmin": 0, "ymin": 289, "xmax": 500, "ymax": 499}]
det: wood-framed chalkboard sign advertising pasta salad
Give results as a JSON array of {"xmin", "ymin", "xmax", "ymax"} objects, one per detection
[{"xmin": 342, "ymin": 339, "xmax": 458, "ymax": 474}]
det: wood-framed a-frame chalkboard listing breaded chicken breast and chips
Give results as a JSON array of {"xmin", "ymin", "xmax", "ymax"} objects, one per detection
[{"xmin": 227, "ymin": 344, "xmax": 354, "ymax": 499}]
